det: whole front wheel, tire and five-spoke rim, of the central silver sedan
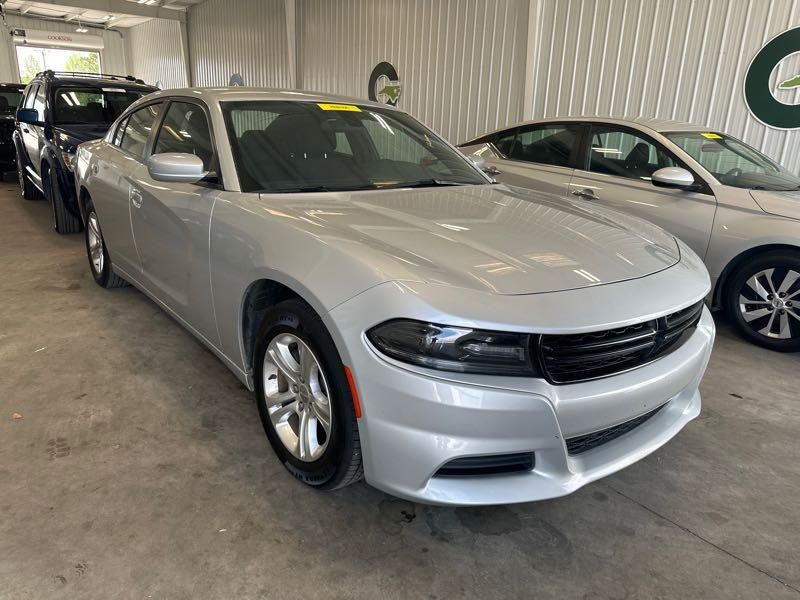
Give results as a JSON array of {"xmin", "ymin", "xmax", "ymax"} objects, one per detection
[{"xmin": 255, "ymin": 299, "xmax": 363, "ymax": 490}]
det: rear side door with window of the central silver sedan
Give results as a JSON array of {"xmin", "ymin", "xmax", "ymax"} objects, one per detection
[{"xmin": 91, "ymin": 102, "xmax": 163, "ymax": 279}]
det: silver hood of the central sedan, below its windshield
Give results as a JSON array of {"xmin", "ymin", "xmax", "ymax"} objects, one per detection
[{"xmin": 262, "ymin": 185, "xmax": 680, "ymax": 294}]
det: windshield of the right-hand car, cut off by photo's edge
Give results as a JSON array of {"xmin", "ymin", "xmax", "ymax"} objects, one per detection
[{"xmin": 665, "ymin": 131, "xmax": 800, "ymax": 191}]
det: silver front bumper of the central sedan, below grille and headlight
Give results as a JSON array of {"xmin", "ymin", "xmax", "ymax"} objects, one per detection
[{"xmin": 328, "ymin": 298, "xmax": 715, "ymax": 505}]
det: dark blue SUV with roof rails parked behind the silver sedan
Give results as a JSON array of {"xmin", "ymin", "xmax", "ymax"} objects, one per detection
[{"xmin": 14, "ymin": 71, "xmax": 158, "ymax": 233}]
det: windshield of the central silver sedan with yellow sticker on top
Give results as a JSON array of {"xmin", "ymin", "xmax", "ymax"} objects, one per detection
[{"xmin": 222, "ymin": 100, "xmax": 487, "ymax": 192}]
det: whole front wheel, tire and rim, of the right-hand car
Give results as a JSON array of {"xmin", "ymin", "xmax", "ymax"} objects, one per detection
[{"xmin": 725, "ymin": 250, "xmax": 800, "ymax": 352}]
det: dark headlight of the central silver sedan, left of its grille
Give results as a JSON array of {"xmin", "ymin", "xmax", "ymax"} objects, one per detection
[{"xmin": 367, "ymin": 319, "xmax": 539, "ymax": 377}]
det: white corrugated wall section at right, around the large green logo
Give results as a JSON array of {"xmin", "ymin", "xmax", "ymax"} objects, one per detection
[{"xmin": 525, "ymin": 0, "xmax": 800, "ymax": 172}]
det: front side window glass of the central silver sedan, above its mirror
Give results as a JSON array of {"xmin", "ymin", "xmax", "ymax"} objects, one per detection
[{"xmin": 153, "ymin": 102, "xmax": 216, "ymax": 170}]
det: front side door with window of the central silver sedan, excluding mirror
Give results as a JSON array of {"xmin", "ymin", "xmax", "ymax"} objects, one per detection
[{"xmin": 130, "ymin": 100, "xmax": 221, "ymax": 343}]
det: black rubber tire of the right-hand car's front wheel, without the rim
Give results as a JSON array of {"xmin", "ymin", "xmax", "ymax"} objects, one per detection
[{"xmin": 725, "ymin": 252, "xmax": 800, "ymax": 352}]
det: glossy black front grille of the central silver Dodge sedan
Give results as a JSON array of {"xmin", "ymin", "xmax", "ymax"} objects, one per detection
[{"xmin": 539, "ymin": 302, "xmax": 703, "ymax": 383}]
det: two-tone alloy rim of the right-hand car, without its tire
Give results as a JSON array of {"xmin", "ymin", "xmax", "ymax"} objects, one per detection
[{"xmin": 738, "ymin": 267, "xmax": 800, "ymax": 340}]
